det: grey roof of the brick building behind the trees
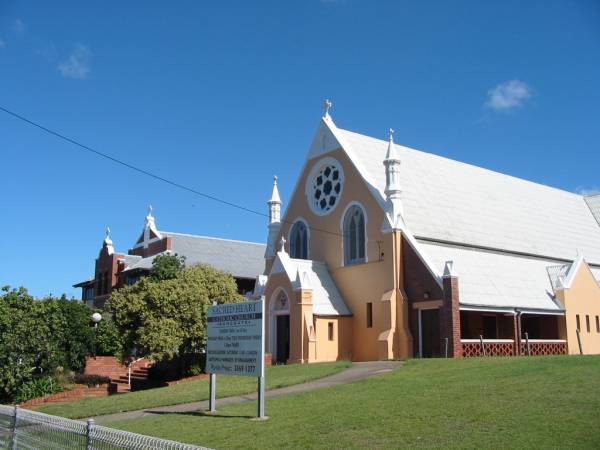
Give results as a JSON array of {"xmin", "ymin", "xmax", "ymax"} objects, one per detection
[{"xmin": 123, "ymin": 231, "xmax": 265, "ymax": 278}]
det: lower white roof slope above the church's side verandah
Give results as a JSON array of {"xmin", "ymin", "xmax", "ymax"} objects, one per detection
[{"xmin": 421, "ymin": 242, "xmax": 563, "ymax": 311}]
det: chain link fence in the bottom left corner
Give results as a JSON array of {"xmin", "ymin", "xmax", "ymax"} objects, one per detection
[{"xmin": 0, "ymin": 405, "xmax": 211, "ymax": 450}]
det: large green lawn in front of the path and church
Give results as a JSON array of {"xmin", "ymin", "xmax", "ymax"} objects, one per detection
[{"xmin": 110, "ymin": 356, "xmax": 600, "ymax": 449}]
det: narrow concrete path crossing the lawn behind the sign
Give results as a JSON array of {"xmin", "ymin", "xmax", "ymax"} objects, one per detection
[{"xmin": 94, "ymin": 361, "xmax": 402, "ymax": 423}]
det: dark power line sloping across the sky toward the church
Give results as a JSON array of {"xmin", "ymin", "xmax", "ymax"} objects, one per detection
[{"xmin": 0, "ymin": 106, "xmax": 343, "ymax": 236}]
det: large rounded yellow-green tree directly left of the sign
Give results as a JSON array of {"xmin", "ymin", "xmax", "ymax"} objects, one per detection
[{"xmin": 107, "ymin": 265, "xmax": 243, "ymax": 361}]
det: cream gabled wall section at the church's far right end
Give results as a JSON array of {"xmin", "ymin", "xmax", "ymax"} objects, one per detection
[{"xmin": 557, "ymin": 262, "xmax": 600, "ymax": 355}]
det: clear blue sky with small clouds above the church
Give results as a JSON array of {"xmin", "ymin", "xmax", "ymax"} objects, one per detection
[{"xmin": 0, "ymin": 0, "xmax": 600, "ymax": 296}]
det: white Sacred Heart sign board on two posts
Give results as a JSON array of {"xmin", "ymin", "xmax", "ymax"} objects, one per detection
[{"xmin": 206, "ymin": 301, "xmax": 265, "ymax": 377}]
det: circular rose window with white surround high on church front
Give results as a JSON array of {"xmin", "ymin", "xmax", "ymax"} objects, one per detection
[{"xmin": 306, "ymin": 158, "xmax": 344, "ymax": 216}]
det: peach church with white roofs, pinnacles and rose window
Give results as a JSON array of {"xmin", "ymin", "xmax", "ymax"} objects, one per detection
[{"xmin": 254, "ymin": 102, "xmax": 600, "ymax": 363}]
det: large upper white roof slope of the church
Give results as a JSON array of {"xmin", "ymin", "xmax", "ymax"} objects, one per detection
[{"xmin": 331, "ymin": 124, "xmax": 600, "ymax": 264}]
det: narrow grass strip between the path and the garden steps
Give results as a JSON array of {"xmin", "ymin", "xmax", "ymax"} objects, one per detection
[{"xmin": 35, "ymin": 361, "xmax": 351, "ymax": 419}]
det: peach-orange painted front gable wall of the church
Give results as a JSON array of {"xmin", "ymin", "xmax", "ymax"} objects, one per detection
[{"xmin": 269, "ymin": 149, "xmax": 397, "ymax": 361}]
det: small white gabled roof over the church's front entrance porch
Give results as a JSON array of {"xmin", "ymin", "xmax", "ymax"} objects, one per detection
[{"xmin": 271, "ymin": 252, "xmax": 352, "ymax": 316}]
